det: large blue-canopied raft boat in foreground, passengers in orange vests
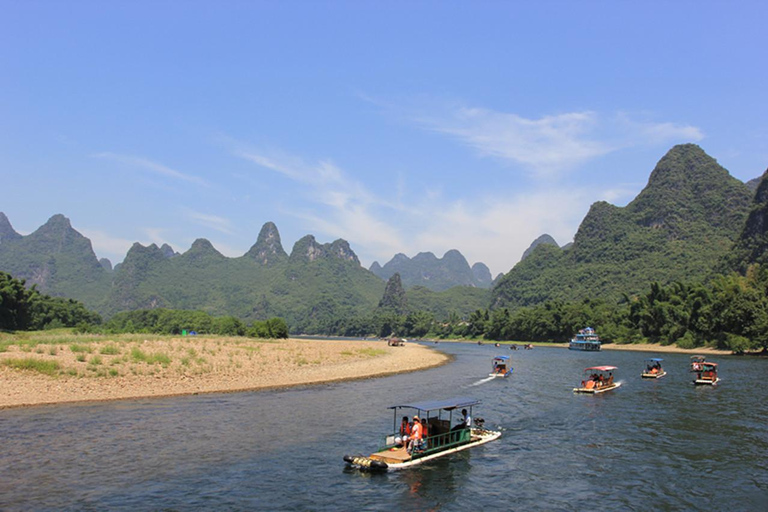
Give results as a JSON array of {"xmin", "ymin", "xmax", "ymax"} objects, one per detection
[{"xmin": 344, "ymin": 397, "xmax": 501, "ymax": 471}]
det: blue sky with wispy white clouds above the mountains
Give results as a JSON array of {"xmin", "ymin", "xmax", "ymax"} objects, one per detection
[{"xmin": 0, "ymin": 0, "xmax": 768, "ymax": 276}]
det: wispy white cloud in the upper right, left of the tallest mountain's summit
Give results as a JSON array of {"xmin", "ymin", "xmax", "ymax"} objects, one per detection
[{"xmin": 374, "ymin": 94, "xmax": 704, "ymax": 178}]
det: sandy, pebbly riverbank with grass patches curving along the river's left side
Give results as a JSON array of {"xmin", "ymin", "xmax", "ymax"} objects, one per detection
[{"xmin": 0, "ymin": 337, "xmax": 450, "ymax": 409}]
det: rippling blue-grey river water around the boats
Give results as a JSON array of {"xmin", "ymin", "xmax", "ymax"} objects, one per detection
[{"xmin": 0, "ymin": 343, "xmax": 768, "ymax": 511}]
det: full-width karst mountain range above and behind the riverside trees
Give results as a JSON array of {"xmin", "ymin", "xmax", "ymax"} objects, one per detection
[{"xmin": 0, "ymin": 144, "xmax": 768, "ymax": 332}]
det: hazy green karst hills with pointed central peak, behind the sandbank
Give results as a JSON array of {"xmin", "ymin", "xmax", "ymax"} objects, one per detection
[{"xmin": 107, "ymin": 230, "xmax": 384, "ymax": 333}]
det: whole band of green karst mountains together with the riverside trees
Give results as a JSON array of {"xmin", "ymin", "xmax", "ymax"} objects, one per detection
[{"xmin": 0, "ymin": 144, "xmax": 768, "ymax": 351}]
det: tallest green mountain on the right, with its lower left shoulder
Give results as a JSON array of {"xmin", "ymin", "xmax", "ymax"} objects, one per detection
[{"xmin": 492, "ymin": 144, "xmax": 751, "ymax": 309}]
